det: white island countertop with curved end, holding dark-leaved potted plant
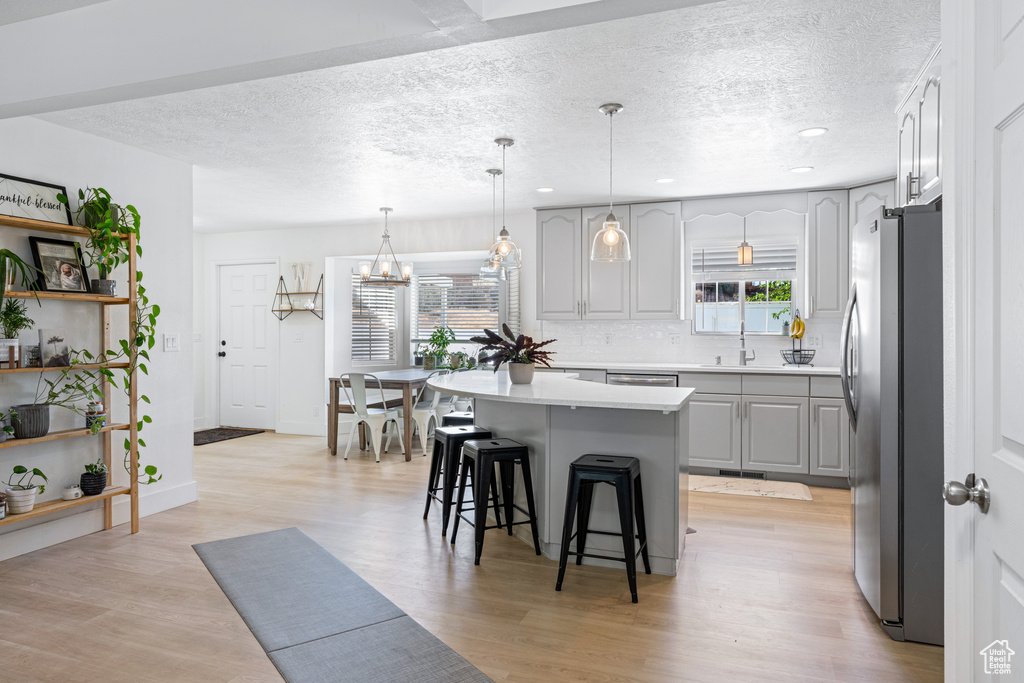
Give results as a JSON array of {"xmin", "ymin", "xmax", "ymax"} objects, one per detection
[{"xmin": 427, "ymin": 371, "xmax": 693, "ymax": 412}]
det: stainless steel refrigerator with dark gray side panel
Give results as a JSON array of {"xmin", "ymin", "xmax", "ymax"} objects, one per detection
[{"xmin": 840, "ymin": 205, "xmax": 943, "ymax": 645}]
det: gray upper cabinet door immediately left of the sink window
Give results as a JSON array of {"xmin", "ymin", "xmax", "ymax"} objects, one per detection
[{"xmin": 629, "ymin": 202, "xmax": 682, "ymax": 321}]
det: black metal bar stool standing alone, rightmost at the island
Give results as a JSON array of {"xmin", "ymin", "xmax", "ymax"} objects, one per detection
[{"xmin": 557, "ymin": 454, "xmax": 650, "ymax": 602}]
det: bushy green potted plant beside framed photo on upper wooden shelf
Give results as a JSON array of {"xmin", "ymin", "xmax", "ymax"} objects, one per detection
[{"xmin": 57, "ymin": 187, "xmax": 141, "ymax": 296}]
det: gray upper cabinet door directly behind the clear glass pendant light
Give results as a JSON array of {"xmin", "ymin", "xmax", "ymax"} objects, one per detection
[{"xmin": 581, "ymin": 206, "xmax": 636, "ymax": 321}]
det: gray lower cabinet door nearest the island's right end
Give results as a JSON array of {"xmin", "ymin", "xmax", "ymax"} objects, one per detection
[{"xmin": 690, "ymin": 393, "xmax": 740, "ymax": 470}]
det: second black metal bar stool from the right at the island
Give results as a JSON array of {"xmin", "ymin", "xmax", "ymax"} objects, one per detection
[{"xmin": 452, "ymin": 438, "xmax": 541, "ymax": 564}]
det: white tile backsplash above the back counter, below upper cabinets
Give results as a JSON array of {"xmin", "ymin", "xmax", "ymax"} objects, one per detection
[{"xmin": 537, "ymin": 318, "xmax": 842, "ymax": 366}]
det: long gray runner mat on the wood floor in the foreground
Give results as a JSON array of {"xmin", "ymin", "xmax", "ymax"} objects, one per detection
[{"xmin": 193, "ymin": 527, "xmax": 490, "ymax": 683}]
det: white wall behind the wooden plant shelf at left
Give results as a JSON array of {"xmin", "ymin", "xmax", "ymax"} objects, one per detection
[{"xmin": 0, "ymin": 113, "xmax": 197, "ymax": 560}]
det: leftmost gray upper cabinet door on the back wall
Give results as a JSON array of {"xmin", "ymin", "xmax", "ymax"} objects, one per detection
[{"xmin": 537, "ymin": 209, "xmax": 590, "ymax": 321}]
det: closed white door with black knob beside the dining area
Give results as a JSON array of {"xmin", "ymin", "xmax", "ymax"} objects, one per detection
[{"xmin": 216, "ymin": 263, "xmax": 279, "ymax": 429}]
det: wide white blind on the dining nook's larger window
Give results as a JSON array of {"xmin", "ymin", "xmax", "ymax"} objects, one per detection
[{"xmin": 410, "ymin": 272, "xmax": 501, "ymax": 342}]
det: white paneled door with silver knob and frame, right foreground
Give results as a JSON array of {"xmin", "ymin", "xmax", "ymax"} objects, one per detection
[{"xmin": 943, "ymin": 0, "xmax": 1024, "ymax": 682}]
